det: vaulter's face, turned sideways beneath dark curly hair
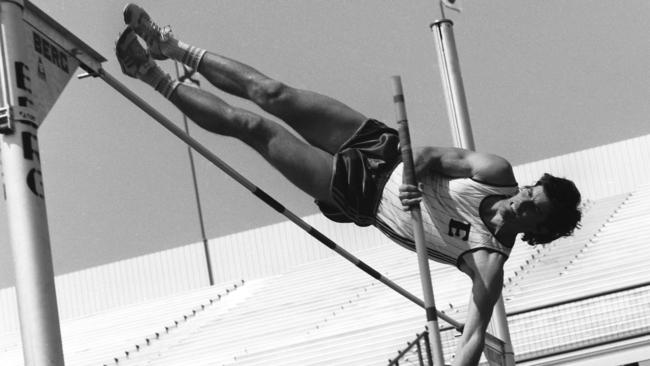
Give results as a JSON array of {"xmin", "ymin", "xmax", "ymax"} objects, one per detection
[{"xmin": 508, "ymin": 186, "xmax": 552, "ymax": 232}]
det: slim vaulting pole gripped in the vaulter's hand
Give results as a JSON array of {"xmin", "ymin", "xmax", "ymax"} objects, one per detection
[{"xmin": 392, "ymin": 76, "xmax": 445, "ymax": 366}]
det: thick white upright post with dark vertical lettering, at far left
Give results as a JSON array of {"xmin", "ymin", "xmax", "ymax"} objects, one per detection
[{"xmin": 0, "ymin": 0, "xmax": 64, "ymax": 366}]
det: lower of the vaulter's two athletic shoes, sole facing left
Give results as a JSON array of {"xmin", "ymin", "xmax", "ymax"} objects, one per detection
[{"xmin": 115, "ymin": 27, "xmax": 156, "ymax": 79}]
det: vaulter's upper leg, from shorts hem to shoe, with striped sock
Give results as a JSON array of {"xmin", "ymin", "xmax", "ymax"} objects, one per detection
[{"xmin": 124, "ymin": 4, "xmax": 366, "ymax": 154}]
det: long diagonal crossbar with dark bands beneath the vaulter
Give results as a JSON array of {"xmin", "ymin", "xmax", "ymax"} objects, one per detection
[{"xmin": 91, "ymin": 68, "xmax": 503, "ymax": 348}]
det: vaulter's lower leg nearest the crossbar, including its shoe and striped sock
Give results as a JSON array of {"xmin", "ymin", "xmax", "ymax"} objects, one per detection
[{"xmin": 116, "ymin": 29, "xmax": 332, "ymax": 201}]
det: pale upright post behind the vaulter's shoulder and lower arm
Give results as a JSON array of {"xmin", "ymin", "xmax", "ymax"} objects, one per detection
[{"xmin": 431, "ymin": 13, "xmax": 515, "ymax": 366}]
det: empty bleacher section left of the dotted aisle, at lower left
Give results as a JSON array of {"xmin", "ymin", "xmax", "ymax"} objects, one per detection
[{"xmin": 0, "ymin": 284, "xmax": 250, "ymax": 365}]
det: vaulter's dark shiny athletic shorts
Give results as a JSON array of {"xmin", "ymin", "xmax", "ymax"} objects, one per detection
[{"xmin": 316, "ymin": 119, "xmax": 401, "ymax": 226}]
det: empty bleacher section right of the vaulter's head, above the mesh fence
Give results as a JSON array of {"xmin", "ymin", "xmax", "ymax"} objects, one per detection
[{"xmin": 505, "ymin": 187, "xmax": 650, "ymax": 312}]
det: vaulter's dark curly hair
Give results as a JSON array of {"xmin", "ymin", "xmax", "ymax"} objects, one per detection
[{"xmin": 521, "ymin": 173, "xmax": 582, "ymax": 245}]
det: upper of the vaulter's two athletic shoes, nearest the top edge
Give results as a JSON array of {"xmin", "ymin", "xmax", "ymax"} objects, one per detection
[{"xmin": 123, "ymin": 4, "xmax": 172, "ymax": 60}]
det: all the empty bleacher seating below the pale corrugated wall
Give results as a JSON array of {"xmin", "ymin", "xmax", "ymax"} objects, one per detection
[{"xmin": 0, "ymin": 187, "xmax": 650, "ymax": 366}]
